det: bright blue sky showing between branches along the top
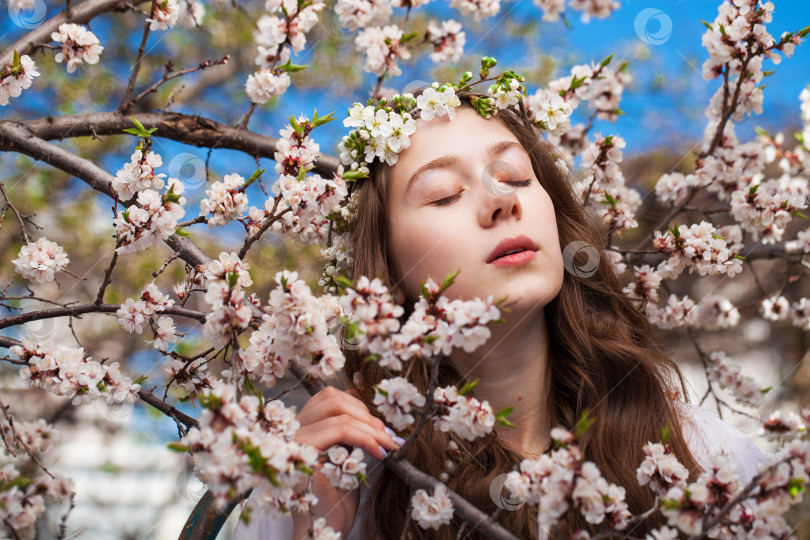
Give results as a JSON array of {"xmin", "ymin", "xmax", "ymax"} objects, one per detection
[{"xmin": 0, "ymin": 0, "xmax": 810, "ymax": 181}]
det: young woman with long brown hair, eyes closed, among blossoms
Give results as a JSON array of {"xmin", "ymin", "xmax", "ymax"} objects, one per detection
[{"xmin": 233, "ymin": 86, "xmax": 762, "ymax": 540}]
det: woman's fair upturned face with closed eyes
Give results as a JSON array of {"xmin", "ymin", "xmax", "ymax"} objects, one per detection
[{"xmin": 388, "ymin": 107, "xmax": 563, "ymax": 312}]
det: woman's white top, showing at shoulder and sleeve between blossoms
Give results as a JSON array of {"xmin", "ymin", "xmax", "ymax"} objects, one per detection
[{"xmin": 231, "ymin": 401, "xmax": 764, "ymax": 540}]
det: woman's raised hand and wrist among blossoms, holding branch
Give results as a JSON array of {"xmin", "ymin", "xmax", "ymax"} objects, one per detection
[{"xmin": 292, "ymin": 386, "xmax": 398, "ymax": 539}]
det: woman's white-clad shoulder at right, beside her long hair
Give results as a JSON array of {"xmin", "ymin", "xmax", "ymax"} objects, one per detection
[{"xmin": 675, "ymin": 400, "xmax": 765, "ymax": 485}]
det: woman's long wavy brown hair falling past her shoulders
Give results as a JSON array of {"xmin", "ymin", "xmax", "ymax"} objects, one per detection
[{"xmin": 334, "ymin": 89, "xmax": 702, "ymax": 540}]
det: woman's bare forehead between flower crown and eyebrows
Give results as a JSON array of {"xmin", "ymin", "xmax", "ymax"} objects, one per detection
[{"xmin": 391, "ymin": 107, "xmax": 525, "ymax": 189}]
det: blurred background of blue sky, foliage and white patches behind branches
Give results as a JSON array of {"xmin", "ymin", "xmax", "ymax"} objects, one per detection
[{"xmin": 0, "ymin": 0, "xmax": 810, "ymax": 539}]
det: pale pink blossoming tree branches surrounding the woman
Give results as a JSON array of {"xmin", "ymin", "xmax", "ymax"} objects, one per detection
[{"xmin": 0, "ymin": 0, "xmax": 810, "ymax": 539}]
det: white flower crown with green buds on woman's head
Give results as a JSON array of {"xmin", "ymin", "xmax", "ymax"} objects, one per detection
[{"xmin": 319, "ymin": 56, "xmax": 529, "ymax": 293}]
